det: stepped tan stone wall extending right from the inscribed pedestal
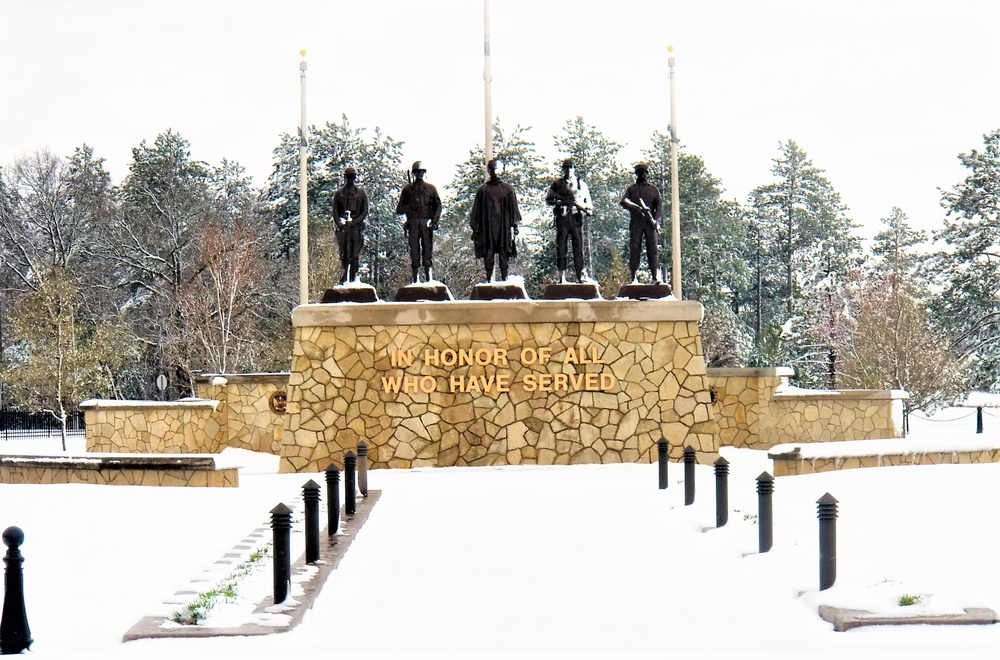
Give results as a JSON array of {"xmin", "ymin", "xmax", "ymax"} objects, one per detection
[{"xmin": 708, "ymin": 367, "xmax": 908, "ymax": 449}]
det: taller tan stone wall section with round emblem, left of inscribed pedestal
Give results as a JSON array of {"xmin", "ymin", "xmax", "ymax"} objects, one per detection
[{"xmin": 195, "ymin": 373, "xmax": 288, "ymax": 454}]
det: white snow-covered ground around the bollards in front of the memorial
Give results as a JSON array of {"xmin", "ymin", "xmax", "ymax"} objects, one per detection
[{"xmin": 0, "ymin": 409, "xmax": 1000, "ymax": 660}]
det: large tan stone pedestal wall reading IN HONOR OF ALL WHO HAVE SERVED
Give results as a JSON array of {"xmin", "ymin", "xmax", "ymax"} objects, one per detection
[{"xmin": 281, "ymin": 300, "xmax": 719, "ymax": 471}]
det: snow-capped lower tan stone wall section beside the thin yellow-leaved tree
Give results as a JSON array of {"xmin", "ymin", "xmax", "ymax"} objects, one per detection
[{"xmin": 80, "ymin": 399, "xmax": 226, "ymax": 454}]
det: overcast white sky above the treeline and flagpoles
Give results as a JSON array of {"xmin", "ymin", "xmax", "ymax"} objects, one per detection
[{"xmin": 0, "ymin": 0, "xmax": 1000, "ymax": 240}]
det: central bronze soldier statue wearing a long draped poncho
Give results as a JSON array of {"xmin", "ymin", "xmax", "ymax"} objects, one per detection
[{"xmin": 469, "ymin": 158, "xmax": 521, "ymax": 282}]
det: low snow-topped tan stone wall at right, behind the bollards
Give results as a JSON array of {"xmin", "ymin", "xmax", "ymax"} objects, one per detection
[{"xmin": 767, "ymin": 438, "xmax": 1000, "ymax": 477}]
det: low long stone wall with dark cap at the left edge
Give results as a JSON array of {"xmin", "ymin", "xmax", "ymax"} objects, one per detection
[{"xmin": 0, "ymin": 454, "xmax": 239, "ymax": 487}]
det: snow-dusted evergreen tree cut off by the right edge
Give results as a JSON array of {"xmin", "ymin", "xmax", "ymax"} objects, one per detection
[{"xmin": 932, "ymin": 129, "xmax": 1000, "ymax": 390}]
